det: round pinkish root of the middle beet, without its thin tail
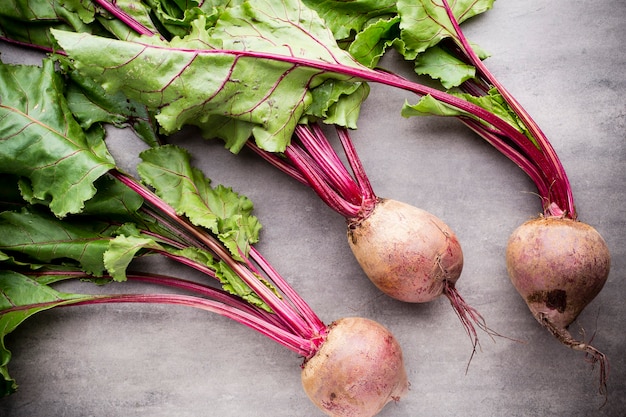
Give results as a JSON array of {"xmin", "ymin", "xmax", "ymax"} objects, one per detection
[{"xmin": 348, "ymin": 199, "xmax": 463, "ymax": 303}]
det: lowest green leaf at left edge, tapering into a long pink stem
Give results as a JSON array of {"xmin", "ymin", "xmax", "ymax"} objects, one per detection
[{"xmin": 0, "ymin": 269, "xmax": 93, "ymax": 396}]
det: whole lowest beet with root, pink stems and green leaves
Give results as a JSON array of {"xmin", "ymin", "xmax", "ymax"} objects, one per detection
[{"xmin": 0, "ymin": 59, "xmax": 408, "ymax": 416}]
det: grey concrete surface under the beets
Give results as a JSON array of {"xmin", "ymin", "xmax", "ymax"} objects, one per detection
[{"xmin": 0, "ymin": 0, "xmax": 626, "ymax": 417}]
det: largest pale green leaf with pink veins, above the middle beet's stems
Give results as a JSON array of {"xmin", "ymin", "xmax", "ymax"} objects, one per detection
[{"xmin": 53, "ymin": 0, "xmax": 366, "ymax": 152}]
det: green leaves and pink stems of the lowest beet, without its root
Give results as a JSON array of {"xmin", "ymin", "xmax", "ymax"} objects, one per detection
[{"xmin": 0, "ymin": 55, "xmax": 325, "ymax": 380}]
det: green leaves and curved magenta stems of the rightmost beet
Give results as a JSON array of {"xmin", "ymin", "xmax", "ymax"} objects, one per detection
[{"xmin": 311, "ymin": 0, "xmax": 576, "ymax": 219}]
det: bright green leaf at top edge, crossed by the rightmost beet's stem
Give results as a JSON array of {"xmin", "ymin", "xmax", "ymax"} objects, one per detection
[{"xmin": 397, "ymin": 0, "xmax": 494, "ymax": 60}]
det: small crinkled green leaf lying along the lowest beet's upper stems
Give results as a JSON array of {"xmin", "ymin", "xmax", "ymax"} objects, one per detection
[{"xmin": 137, "ymin": 145, "xmax": 261, "ymax": 259}]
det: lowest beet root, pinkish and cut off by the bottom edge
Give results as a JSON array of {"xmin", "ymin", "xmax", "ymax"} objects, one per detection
[{"xmin": 302, "ymin": 317, "xmax": 409, "ymax": 417}]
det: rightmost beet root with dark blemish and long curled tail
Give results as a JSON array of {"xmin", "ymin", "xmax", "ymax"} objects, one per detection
[{"xmin": 506, "ymin": 217, "xmax": 611, "ymax": 394}]
